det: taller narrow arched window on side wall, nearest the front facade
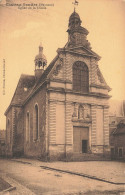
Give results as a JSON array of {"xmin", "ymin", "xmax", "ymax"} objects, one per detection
[{"xmin": 34, "ymin": 104, "xmax": 39, "ymax": 140}]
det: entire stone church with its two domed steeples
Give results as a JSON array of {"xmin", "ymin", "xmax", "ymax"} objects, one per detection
[{"xmin": 5, "ymin": 11, "xmax": 110, "ymax": 160}]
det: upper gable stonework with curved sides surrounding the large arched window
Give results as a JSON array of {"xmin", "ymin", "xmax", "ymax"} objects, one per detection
[{"xmin": 48, "ymin": 47, "xmax": 108, "ymax": 88}]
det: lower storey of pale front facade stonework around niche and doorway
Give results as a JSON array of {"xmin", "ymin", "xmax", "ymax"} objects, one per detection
[{"xmin": 48, "ymin": 92, "xmax": 109, "ymax": 159}]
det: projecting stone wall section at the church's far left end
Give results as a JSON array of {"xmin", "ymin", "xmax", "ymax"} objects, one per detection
[{"xmin": 6, "ymin": 106, "xmax": 24, "ymax": 157}]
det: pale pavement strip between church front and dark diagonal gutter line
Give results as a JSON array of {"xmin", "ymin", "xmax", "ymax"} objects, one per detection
[{"xmin": 12, "ymin": 158, "xmax": 125, "ymax": 184}]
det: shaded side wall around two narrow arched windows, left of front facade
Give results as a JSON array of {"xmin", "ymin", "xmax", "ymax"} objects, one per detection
[{"xmin": 24, "ymin": 86, "xmax": 46, "ymax": 158}]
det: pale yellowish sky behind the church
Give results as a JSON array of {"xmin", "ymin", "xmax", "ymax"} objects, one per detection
[{"xmin": 0, "ymin": 0, "xmax": 125, "ymax": 129}]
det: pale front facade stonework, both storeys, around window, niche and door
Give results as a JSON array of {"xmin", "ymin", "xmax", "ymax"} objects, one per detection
[{"xmin": 48, "ymin": 53, "xmax": 109, "ymax": 159}]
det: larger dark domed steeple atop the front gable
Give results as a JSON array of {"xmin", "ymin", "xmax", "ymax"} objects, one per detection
[{"xmin": 67, "ymin": 9, "xmax": 91, "ymax": 49}]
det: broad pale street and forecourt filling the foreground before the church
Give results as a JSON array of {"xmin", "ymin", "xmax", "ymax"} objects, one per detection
[{"xmin": 0, "ymin": 159, "xmax": 125, "ymax": 195}]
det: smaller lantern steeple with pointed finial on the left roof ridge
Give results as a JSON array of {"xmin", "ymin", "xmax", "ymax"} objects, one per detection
[{"xmin": 34, "ymin": 43, "xmax": 47, "ymax": 79}]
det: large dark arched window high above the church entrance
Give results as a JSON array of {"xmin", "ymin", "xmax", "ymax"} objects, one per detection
[{"xmin": 73, "ymin": 61, "xmax": 89, "ymax": 93}]
